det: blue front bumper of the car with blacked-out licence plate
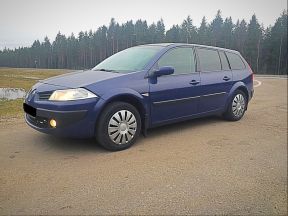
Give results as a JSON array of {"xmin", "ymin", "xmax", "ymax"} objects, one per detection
[{"xmin": 23, "ymin": 98, "xmax": 103, "ymax": 138}]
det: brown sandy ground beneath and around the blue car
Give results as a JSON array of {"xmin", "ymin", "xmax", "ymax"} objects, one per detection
[{"xmin": 0, "ymin": 78, "xmax": 287, "ymax": 215}]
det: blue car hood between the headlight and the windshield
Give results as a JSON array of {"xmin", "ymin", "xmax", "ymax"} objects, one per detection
[{"xmin": 39, "ymin": 70, "xmax": 124, "ymax": 88}]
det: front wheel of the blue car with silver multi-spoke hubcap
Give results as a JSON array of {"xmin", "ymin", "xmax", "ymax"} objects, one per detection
[{"xmin": 96, "ymin": 102, "xmax": 141, "ymax": 151}]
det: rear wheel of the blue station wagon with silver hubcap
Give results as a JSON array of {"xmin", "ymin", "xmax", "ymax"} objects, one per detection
[{"xmin": 224, "ymin": 90, "xmax": 247, "ymax": 121}]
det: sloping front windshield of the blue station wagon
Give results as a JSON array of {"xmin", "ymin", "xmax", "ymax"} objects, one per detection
[{"xmin": 92, "ymin": 46, "xmax": 162, "ymax": 73}]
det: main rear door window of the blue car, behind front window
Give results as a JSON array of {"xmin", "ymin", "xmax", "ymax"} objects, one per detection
[{"xmin": 197, "ymin": 48, "xmax": 221, "ymax": 71}]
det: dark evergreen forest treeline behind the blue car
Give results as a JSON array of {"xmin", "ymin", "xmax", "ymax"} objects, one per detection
[{"xmin": 0, "ymin": 10, "xmax": 288, "ymax": 74}]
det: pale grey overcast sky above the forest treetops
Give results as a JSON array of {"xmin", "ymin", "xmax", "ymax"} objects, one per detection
[{"xmin": 0, "ymin": 0, "xmax": 287, "ymax": 49}]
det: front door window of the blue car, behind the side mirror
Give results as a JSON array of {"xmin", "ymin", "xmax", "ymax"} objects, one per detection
[{"xmin": 158, "ymin": 47, "xmax": 196, "ymax": 74}]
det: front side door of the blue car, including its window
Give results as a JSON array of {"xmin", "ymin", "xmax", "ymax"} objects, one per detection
[{"xmin": 149, "ymin": 47, "xmax": 201, "ymax": 125}]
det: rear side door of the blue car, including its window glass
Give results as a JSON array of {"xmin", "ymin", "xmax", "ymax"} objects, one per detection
[{"xmin": 197, "ymin": 48, "xmax": 233, "ymax": 113}]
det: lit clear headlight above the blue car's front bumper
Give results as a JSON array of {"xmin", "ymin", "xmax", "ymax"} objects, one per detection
[{"xmin": 49, "ymin": 88, "xmax": 97, "ymax": 101}]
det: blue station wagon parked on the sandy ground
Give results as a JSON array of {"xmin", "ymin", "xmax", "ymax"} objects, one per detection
[{"xmin": 23, "ymin": 44, "xmax": 254, "ymax": 151}]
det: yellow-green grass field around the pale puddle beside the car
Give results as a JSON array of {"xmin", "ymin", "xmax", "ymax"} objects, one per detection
[{"xmin": 0, "ymin": 68, "xmax": 70, "ymax": 121}]
